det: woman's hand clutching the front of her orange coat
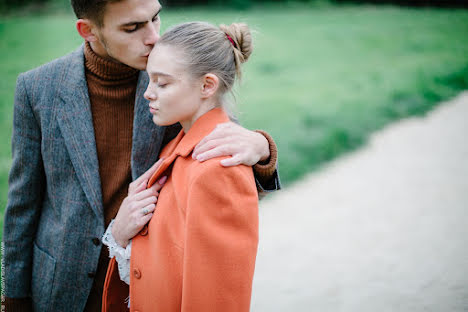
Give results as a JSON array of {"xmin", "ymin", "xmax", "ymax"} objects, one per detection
[{"xmin": 112, "ymin": 159, "xmax": 167, "ymax": 248}]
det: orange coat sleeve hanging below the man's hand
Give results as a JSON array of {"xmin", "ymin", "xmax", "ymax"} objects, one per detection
[{"xmin": 182, "ymin": 160, "xmax": 258, "ymax": 311}]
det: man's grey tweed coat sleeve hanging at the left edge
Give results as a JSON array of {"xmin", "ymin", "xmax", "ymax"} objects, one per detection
[{"xmin": 3, "ymin": 75, "xmax": 45, "ymax": 298}]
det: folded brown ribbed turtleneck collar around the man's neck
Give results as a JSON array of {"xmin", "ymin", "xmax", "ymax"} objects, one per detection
[{"xmin": 84, "ymin": 42, "xmax": 140, "ymax": 81}]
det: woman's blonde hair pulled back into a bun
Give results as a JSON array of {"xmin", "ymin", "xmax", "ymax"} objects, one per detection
[{"xmin": 158, "ymin": 22, "xmax": 253, "ymax": 95}]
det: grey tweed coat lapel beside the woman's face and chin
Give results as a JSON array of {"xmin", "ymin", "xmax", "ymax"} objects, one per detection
[{"xmin": 131, "ymin": 71, "xmax": 166, "ymax": 180}]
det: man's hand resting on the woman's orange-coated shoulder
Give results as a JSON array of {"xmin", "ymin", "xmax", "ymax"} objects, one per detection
[{"xmin": 192, "ymin": 122, "xmax": 270, "ymax": 167}]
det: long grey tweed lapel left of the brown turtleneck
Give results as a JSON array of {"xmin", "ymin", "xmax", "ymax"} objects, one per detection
[{"xmin": 57, "ymin": 46, "xmax": 103, "ymax": 218}]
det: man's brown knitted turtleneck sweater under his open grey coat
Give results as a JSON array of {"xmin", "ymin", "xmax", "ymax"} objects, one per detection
[{"xmin": 85, "ymin": 43, "xmax": 140, "ymax": 312}]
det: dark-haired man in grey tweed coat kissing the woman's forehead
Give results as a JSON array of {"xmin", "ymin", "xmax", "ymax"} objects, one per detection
[{"xmin": 3, "ymin": 0, "xmax": 280, "ymax": 312}]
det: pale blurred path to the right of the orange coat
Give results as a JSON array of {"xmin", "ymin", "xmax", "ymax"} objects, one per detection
[{"xmin": 251, "ymin": 92, "xmax": 468, "ymax": 312}]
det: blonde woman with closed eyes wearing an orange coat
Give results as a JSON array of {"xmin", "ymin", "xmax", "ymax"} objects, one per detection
[{"xmin": 103, "ymin": 22, "xmax": 258, "ymax": 312}]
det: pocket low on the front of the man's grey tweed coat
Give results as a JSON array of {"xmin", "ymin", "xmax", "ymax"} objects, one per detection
[{"xmin": 31, "ymin": 242, "xmax": 56, "ymax": 311}]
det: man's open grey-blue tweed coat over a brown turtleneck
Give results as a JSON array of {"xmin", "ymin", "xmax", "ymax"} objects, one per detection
[{"xmin": 3, "ymin": 47, "xmax": 180, "ymax": 312}]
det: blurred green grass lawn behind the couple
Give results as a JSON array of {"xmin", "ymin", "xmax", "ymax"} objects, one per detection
[{"xmin": 0, "ymin": 6, "xmax": 468, "ymax": 236}]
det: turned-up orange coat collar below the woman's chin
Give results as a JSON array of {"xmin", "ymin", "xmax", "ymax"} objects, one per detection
[{"xmin": 148, "ymin": 108, "xmax": 229, "ymax": 188}]
